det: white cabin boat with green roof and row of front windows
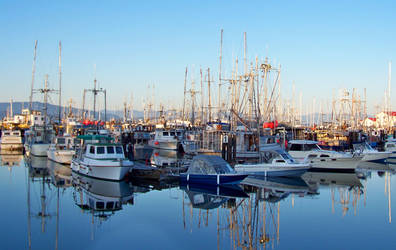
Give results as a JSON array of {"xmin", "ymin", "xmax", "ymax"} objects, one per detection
[{"xmin": 71, "ymin": 135, "xmax": 134, "ymax": 181}]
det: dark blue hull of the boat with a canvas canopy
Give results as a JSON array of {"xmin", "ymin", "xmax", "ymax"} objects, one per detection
[{"xmin": 180, "ymin": 173, "xmax": 248, "ymax": 185}]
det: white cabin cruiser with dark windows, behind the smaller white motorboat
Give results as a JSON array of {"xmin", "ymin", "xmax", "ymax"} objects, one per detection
[{"xmin": 288, "ymin": 140, "xmax": 363, "ymax": 172}]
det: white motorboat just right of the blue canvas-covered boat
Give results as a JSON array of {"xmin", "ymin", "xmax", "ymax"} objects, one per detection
[{"xmin": 235, "ymin": 144, "xmax": 311, "ymax": 176}]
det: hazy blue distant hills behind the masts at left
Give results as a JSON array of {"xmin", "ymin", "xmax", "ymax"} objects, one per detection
[{"xmin": 0, "ymin": 102, "xmax": 143, "ymax": 120}]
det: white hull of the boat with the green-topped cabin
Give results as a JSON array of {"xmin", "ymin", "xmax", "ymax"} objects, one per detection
[{"xmin": 71, "ymin": 159, "xmax": 133, "ymax": 181}]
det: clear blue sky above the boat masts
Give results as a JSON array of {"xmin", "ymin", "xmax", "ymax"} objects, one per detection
[{"xmin": 0, "ymin": 0, "xmax": 396, "ymax": 112}]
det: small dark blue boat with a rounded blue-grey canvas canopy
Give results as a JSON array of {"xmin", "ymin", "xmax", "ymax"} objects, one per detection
[{"xmin": 180, "ymin": 155, "xmax": 248, "ymax": 185}]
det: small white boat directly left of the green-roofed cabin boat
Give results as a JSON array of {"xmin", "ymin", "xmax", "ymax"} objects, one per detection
[{"xmin": 47, "ymin": 134, "xmax": 80, "ymax": 164}]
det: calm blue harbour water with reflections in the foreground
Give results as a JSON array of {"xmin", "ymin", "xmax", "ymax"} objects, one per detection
[{"xmin": 0, "ymin": 154, "xmax": 396, "ymax": 249}]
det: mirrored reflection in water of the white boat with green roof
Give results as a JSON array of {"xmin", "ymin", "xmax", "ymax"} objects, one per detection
[{"xmin": 72, "ymin": 172, "xmax": 133, "ymax": 223}]
